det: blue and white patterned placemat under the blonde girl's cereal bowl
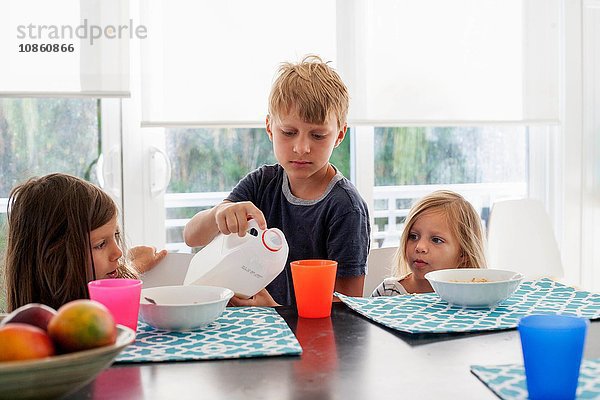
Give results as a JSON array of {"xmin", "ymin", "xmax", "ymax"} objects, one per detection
[{"xmin": 336, "ymin": 279, "xmax": 600, "ymax": 333}]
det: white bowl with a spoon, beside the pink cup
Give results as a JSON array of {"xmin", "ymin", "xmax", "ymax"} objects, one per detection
[{"xmin": 140, "ymin": 285, "xmax": 233, "ymax": 331}]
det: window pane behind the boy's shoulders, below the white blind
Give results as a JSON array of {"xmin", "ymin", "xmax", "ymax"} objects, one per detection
[{"xmin": 165, "ymin": 128, "xmax": 350, "ymax": 251}]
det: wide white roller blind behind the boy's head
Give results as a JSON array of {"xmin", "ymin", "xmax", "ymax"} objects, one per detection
[{"xmin": 142, "ymin": 0, "xmax": 560, "ymax": 126}]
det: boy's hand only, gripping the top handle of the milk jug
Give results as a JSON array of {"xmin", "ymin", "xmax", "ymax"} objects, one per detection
[{"xmin": 215, "ymin": 201, "xmax": 267, "ymax": 237}]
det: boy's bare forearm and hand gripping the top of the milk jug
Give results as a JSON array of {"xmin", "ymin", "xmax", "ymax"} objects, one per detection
[{"xmin": 183, "ymin": 200, "xmax": 267, "ymax": 247}]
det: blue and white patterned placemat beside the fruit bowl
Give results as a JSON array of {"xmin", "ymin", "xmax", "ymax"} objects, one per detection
[{"xmin": 116, "ymin": 307, "xmax": 302, "ymax": 362}]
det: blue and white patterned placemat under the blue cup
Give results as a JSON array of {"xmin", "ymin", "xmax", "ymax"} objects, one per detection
[{"xmin": 471, "ymin": 358, "xmax": 600, "ymax": 400}]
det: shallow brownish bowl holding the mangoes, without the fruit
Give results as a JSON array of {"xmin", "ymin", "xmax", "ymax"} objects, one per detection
[{"xmin": 0, "ymin": 325, "xmax": 135, "ymax": 399}]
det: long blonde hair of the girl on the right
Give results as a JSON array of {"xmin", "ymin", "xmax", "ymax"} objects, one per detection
[{"xmin": 392, "ymin": 190, "xmax": 487, "ymax": 277}]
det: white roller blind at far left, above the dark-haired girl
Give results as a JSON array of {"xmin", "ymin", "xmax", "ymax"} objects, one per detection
[{"xmin": 0, "ymin": 0, "xmax": 131, "ymax": 97}]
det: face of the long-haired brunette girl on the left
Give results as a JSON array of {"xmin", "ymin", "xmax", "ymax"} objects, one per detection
[{"xmin": 90, "ymin": 216, "xmax": 123, "ymax": 279}]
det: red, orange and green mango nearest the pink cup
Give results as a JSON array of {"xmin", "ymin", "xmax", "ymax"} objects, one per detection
[{"xmin": 48, "ymin": 299, "xmax": 117, "ymax": 352}]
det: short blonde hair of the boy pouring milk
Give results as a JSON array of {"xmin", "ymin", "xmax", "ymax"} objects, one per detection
[{"xmin": 269, "ymin": 55, "xmax": 349, "ymax": 128}]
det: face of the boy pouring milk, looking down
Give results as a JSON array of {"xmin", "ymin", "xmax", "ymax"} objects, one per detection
[{"xmin": 267, "ymin": 112, "xmax": 347, "ymax": 183}]
